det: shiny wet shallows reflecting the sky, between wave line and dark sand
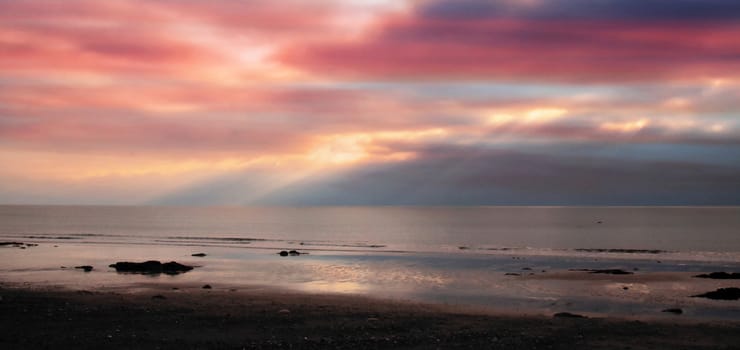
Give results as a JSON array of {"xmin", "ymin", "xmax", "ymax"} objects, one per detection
[{"xmin": 0, "ymin": 243, "xmax": 740, "ymax": 318}]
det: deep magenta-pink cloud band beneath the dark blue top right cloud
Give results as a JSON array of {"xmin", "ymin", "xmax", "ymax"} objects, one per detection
[{"xmin": 276, "ymin": 12, "xmax": 740, "ymax": 82}]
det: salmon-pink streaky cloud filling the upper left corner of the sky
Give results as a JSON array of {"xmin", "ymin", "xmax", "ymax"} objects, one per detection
[{"xmin": 0, "ymin": 0, "xmax": 356, "ymax": 79}]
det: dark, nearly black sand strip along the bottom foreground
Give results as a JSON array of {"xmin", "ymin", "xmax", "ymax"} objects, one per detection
[{"xmin": 0, "ymin": 283, "xmax": 740, "ymax": 349}]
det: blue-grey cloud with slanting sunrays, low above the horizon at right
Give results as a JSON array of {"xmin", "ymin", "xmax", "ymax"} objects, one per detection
[{"xmin": 156, "ymin": 145, "xmax": 740, "ymax": 205}]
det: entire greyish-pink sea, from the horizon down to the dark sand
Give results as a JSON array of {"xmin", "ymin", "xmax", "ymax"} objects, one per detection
[{"xmin": 0, "ymin": 205, "xmax": 740, "ymax": 320}]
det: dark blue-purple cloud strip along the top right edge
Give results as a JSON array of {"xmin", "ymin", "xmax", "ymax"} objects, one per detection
[{"xmin": 420, "ymin": 0, "xmax": 740, "ymax": 21}]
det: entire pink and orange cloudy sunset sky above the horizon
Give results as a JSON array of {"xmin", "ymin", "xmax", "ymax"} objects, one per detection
[{"xmin": 0, "ymin": 0, "xmax": 740, "ymax": 205}]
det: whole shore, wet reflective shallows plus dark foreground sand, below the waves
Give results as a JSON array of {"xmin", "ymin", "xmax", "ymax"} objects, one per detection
[{"xmin": 5, "ymin": 238, "xmax": 740, "ymax": 349}]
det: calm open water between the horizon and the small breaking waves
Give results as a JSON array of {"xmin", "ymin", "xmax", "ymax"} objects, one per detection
[{"xmin": 0, "ymin": 206, "xmax": 740, "ymax": 260}]
